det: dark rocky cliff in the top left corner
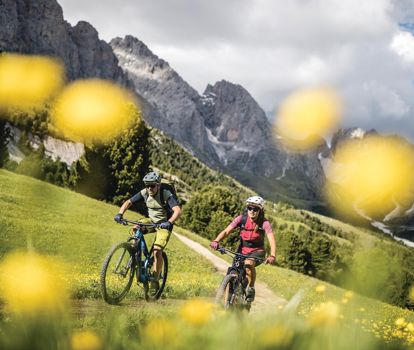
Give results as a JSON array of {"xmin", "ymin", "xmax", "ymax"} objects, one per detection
[{"xmin": 0, "ymin": 0, "xmax": 127, "ymax": 85}]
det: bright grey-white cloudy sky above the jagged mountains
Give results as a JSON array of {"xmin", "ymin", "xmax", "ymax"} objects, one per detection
[{"xmin": 58, "ymin": 0, "xmax": 414, "ymax": 139}]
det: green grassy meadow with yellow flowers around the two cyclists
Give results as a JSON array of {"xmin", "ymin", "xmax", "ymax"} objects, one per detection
[{"xmin": 0, "ymin": 170, "xmax": 414, "ymax": 349}]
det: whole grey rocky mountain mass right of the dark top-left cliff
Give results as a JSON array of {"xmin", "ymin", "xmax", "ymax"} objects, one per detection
[{"xmin": 111, "ymin": 36, "xmax": 324, "ymax": 207}]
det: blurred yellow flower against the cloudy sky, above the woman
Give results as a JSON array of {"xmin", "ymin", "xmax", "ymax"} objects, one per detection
[{"xmin": 274, "ymin": 88, "xmax": 342, "ymax": 151}]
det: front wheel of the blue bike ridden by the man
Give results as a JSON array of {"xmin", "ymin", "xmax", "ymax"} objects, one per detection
[{"xmin": 101, "ymin": 242, "xmax": 136, "ymax": 304}]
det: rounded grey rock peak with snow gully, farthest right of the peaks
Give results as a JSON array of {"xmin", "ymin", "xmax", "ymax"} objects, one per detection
[{"xmin": 199, "ymin": 81, "xmax": 280, "ymax": 170}]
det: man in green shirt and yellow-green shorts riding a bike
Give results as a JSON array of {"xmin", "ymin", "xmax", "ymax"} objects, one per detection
[{"xmin": 114, "ymin": 172, "xmax": 181, "ymax": 291}]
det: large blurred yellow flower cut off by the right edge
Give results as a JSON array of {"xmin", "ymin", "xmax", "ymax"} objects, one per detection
[{"xmin": 326, "ymin": 135, "xmax": 414, "ymax": 220}]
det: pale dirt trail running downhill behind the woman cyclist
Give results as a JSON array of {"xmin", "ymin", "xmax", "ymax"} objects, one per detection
[{"xmin": 174, "ymin": 232, "xmax": 286, "ymax": 312}]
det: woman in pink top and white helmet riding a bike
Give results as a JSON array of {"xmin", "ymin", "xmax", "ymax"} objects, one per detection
[{"xmin": 210, "ymin": 196, "xmax": 276, "ymax": 302}]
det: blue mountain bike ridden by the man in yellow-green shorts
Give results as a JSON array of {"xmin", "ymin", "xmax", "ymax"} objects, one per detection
[{"xmin": 101, "ymin": 219, "xmax": 168, "ymax": 304}]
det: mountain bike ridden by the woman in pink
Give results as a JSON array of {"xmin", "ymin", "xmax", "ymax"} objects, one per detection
[{"xmin": 215, "ymin": 248, "xmax": 264, "ymax": 311}]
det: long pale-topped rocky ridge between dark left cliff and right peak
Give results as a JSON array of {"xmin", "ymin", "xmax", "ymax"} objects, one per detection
[{"xmin": 111, "ymin": 36, "xmax": 218, "ymax": 166}]
